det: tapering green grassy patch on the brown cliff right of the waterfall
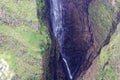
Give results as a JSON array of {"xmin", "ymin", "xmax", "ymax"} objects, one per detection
[{"xmin": 89, "ymin": 0, "xmax": 115, "ymax": 44}]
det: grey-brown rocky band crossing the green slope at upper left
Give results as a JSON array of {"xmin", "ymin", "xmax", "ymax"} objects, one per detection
[{"xmin": 0, "ymin": 7, "xmax": 40, "ymax": 30}]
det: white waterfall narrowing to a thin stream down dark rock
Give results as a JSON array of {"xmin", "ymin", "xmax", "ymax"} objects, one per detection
[{"xmin": 50, "ymin": 0, "xmax": 73, "ymax": 80}]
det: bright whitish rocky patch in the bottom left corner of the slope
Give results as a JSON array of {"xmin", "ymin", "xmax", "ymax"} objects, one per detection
[{"xmin": 0, "ymin": 59, "xmax": 14, "ymax": 80}]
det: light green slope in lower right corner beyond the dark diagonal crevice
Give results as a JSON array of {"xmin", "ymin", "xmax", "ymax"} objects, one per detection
[{"xmin": 98, "ymin": 24, "xmax": 120, "ymax": 80}]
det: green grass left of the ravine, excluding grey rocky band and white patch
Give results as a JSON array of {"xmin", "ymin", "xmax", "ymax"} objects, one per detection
[{"xmin": 0, "ymin": 0, "xmax": 48, "ymax": 80}]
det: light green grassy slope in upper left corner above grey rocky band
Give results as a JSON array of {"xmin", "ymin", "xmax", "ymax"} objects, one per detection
[{"xmin": 0, "ymin": 0, "xmax": 38, "ymax": 22}]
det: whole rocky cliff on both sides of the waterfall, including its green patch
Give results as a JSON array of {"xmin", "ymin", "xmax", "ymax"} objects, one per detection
[{"xmin": 39, "ymin": 0, "xmax": 119, "ymax": 80}]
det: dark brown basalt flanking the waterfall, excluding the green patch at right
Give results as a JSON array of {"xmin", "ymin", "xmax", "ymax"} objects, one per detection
[{"xmin": 38, "ymin": 0, "xmax": 119, "ymax": 80}]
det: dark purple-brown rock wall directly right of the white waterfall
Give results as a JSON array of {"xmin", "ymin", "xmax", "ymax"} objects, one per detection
[{"xmin": 63, "ymin": 0, "xmax": 94, "ymax": 79}]
